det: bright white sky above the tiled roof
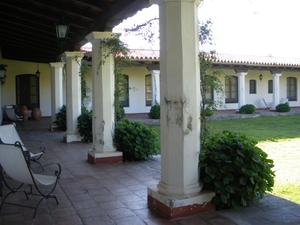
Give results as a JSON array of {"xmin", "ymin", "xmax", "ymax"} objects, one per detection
[{"xmin": 91, "ymin": 0, "xmax": 300, "ymax": 58}]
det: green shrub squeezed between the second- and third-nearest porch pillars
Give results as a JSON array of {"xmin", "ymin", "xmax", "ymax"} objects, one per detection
[{"xmin": 77, "ymin": 109, "xmax": 93, "ymax": 142}]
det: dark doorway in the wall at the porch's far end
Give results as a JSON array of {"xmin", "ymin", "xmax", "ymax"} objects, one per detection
[{"xmin": 16, "ymin": 74, "xmax": 40, "ymax": 110}]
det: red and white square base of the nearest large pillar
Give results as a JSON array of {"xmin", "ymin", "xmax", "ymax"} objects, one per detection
[{"xmin": 148, "ymin": 187, "xmax": 216, "ymax": 219}]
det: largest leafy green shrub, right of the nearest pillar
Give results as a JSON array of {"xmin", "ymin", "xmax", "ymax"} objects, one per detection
[{"xmin": 199, "ymin": 131, "xmax": 275, "ymax": 209}]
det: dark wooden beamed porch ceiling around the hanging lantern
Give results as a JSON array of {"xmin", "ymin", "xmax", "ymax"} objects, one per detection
[{"xmin": 0, "ymin": 0, "xmax": 149, "ymax": 63}]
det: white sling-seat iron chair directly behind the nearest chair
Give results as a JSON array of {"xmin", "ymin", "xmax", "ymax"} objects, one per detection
[{"xmin": 0, "ymin": 124, "xmax": 46, "ymax": 169}]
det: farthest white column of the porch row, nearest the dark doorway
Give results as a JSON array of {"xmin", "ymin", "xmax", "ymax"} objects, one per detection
[{"xmin": 50, "ymin": 62, "xmax": 65, "ymax": 126}]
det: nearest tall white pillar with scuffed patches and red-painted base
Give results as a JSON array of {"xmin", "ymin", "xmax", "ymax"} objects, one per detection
[{"xmin": 148, "ymin": 0, "xmax": 214, "ymax": 218}]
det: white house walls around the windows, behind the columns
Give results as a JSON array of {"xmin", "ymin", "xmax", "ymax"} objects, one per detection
[{"xmin": 1, "ymin": 59, "xmax": 300, "ymax": 117}]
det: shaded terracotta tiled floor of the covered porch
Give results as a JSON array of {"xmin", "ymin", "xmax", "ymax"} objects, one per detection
[{"xmin": 0, "ymin": 116, "xmax": 300, "ymax": 225}]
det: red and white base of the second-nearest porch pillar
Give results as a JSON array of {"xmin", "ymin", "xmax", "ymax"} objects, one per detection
[{"xmin": 88, "ymin": 150, "xmax": 123, "ymax": 164}]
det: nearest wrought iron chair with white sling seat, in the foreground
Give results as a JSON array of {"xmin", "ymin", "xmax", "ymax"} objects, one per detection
[{"xmin": 0, "ymin": 142, "xmax": 61, "ymax": 218}]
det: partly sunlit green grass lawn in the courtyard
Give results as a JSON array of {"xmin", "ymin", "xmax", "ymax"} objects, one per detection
[{"xmin": 147, "ymin": 115, "xmax": 300, "ymax": 204}]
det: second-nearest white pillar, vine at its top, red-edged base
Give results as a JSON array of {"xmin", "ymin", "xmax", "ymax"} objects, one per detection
[{"xmin": 86, "ymin": 32, "xmax": 123, "ymax": 163}]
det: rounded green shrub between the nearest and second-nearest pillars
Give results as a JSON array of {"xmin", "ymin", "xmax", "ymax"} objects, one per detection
[{"xmin": 114, "ymin": 119, "xmax": 159, "ymax": 161}]
